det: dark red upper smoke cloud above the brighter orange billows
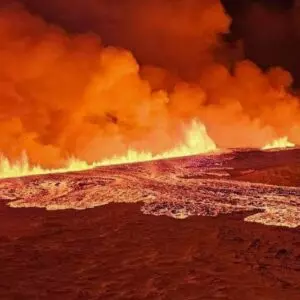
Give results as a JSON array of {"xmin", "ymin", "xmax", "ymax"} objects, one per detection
[{"xmin": 15, "ymin": 0, "xmax": 230, "ymax": 79}]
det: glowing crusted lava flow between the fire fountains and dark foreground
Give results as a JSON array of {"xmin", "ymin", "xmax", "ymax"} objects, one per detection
[{"xmin": 0, "ymin": 149, "xmax": 300, "ymax": 227}]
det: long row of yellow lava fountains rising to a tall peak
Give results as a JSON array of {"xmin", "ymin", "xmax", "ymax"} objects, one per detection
[{"xmin": 0, "ymin": 120, "xmax": 217, "ymax": 178}]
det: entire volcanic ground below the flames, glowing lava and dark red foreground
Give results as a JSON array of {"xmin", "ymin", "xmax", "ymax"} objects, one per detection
[{"xmin": 0, "ymin": 149, "xmax": 300, "ymax": 300}]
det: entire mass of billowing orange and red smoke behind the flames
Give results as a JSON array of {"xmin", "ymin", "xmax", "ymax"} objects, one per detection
[{"xmin": 0, "ymin": 0, "xmax": 300, "ymax": 166}]
